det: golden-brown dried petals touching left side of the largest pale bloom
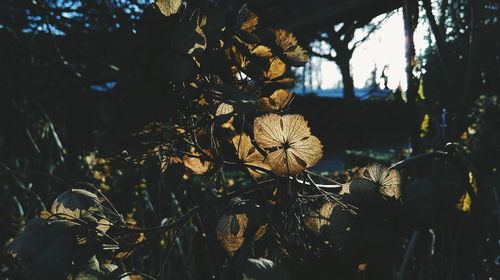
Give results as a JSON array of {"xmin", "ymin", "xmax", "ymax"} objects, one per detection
[{"xmin": 231, "ymin": 133, "xmax": 271, "ymax": 178}]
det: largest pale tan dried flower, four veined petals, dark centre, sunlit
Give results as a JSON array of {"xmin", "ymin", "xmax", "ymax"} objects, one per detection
[{"xmin": 254, "ymin": 114, "xmax": 323, "ymax": 176}]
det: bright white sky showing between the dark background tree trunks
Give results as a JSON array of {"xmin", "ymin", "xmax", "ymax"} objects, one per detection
[{"xmin": 311, "ymin": 9, "xmax": 428, "ymax": 89}]
